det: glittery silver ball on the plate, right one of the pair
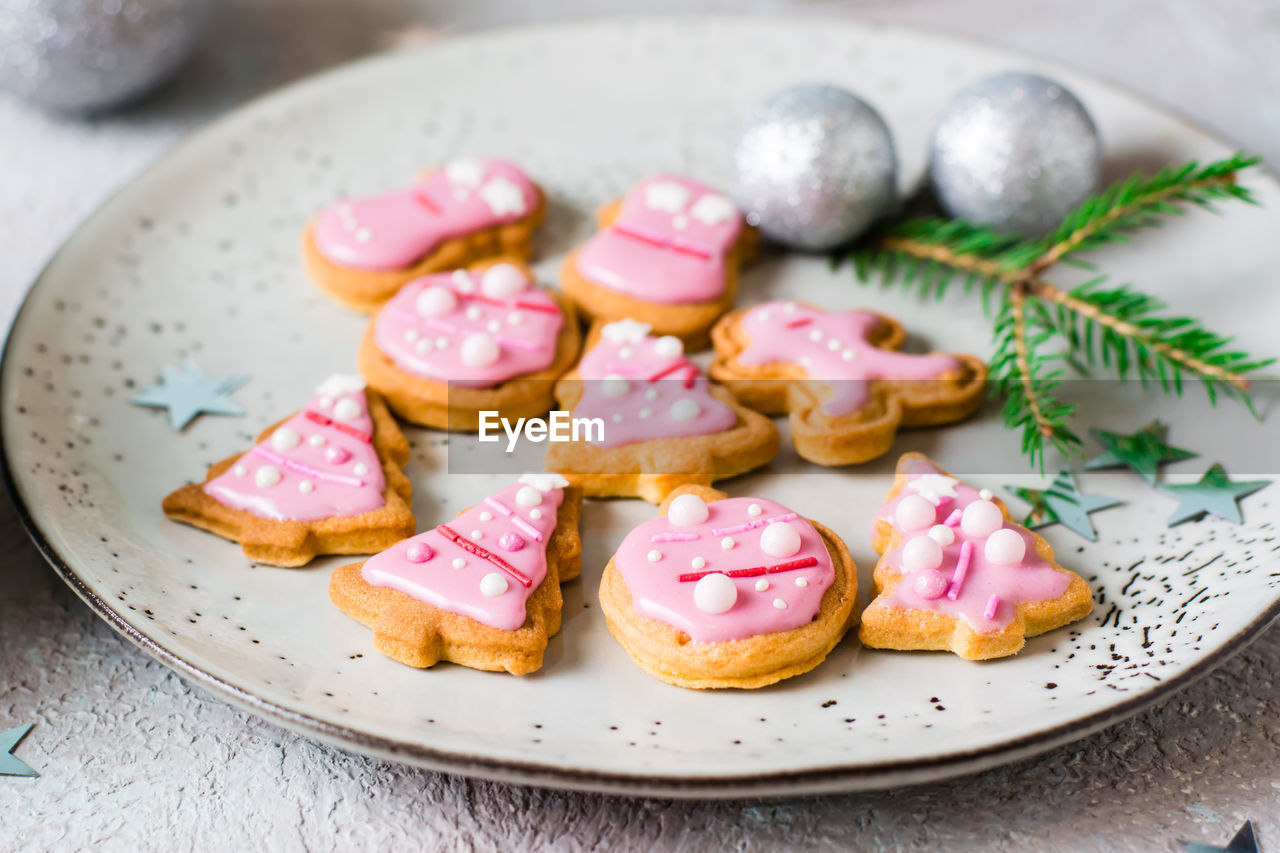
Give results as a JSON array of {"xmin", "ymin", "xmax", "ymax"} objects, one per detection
[{"xmin": 929, "ymin": 72, "xmax": 1102, "ymax": 234}]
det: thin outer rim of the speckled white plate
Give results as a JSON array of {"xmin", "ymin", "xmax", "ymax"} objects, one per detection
[{"xmin": 10, "ymin": 15, "xmax": 1280, "ymax": 799}]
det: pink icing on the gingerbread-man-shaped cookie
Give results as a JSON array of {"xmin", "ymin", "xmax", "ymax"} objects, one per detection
[{"xmin": 737, "ymin": 301, "xmax": 960, "ymax": 415}]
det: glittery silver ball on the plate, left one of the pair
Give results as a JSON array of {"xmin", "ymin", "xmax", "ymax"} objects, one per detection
[{"xmin": 733, "ymin": 83, "xmax": 897, "ymax": 251}]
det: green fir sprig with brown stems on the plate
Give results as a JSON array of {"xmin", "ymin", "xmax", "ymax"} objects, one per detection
[{"xmin": 850, "ymin": 154, "xmax": 1275, "ymax": 469}]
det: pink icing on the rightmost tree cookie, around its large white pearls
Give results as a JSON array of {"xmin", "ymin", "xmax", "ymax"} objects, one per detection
[{"xmin": 873, "ymin": 460, "xmax": 1071, "ymax": 634}]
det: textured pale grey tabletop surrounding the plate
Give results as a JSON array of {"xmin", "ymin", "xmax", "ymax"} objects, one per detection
[{"xmin": 0, "ymin": 0, "xmax": 1280, "ymax": 850}]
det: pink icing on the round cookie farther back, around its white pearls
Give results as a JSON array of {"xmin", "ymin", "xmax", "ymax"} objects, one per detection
[{"xmin": 374, "ymin": 270, "xmax": 564, "ymax": 388}]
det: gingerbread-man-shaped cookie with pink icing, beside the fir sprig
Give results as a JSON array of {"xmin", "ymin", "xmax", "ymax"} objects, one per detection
[{"xmin": 710, "ymin": 301, "xmax": 987, "ymax": 465}]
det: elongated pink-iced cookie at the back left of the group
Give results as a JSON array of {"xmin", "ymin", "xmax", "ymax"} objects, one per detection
[{"xmin": 302, "ymin": 158, "xmax": 547, "ymax": 313}]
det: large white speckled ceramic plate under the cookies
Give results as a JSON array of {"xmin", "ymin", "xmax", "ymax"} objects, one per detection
[{"xmin": 3, "ymin": 19, "xmax": 1280, "ymax": 797}]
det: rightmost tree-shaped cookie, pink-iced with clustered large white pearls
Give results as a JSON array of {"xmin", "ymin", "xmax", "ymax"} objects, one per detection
[{"xmin": 859, "ymin": 453, "xmax": 1093, "ymax": 661}]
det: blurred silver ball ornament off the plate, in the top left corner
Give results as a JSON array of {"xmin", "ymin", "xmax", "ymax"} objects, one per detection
[{"xmin": 0, "ymin": 0, "xmax": 212, "ymax": 111}]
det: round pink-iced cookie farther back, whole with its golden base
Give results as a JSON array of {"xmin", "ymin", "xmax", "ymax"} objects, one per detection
[{"xmin": 360, "ymin": 261, "xmax": 581, "ymax": 430}]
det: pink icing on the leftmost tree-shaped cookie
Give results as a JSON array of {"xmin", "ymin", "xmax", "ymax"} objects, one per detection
[{"xmin": 204, "ymin": 383, "xmax": 387, "ymax": 521}]
